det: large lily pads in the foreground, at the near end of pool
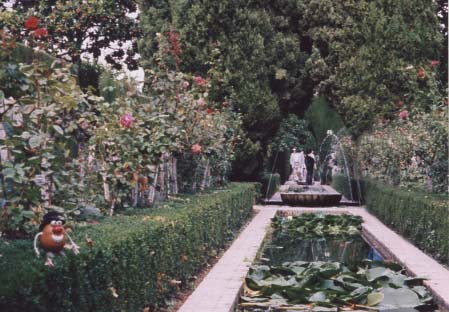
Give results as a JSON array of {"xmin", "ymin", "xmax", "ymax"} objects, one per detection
[{"xmin": 239, "ymin": 260, "xmax": 436, "ymax": 312}]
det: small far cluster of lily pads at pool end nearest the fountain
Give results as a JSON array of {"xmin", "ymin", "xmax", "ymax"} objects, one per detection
[{"xmin": 272, "ymin": 213, "xmax": 363, "ymax": 239}]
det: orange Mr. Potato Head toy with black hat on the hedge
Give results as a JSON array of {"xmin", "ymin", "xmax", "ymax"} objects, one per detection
[{"xmin": 34, "ymin": 211, "xmax": 79, "ymax": 267}]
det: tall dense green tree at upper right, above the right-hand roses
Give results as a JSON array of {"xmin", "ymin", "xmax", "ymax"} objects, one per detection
[{"xmin": 304, "ymin": 0, "xmax": 442, "ymax": 135}]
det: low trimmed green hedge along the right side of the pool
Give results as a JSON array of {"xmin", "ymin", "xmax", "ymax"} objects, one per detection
[{"xmin": 333, "ymin": 176, "xmax": 449, "ymax": 265}]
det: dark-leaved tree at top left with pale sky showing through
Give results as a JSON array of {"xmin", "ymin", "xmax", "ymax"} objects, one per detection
[{"xmin": 3, "ymin": 0, "xmax": 139, "ymax": 70}]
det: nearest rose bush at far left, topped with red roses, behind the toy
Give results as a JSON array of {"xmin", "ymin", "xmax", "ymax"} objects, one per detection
[{"xmin": 0, "ymin": 30, "xmax": 96, "ymax": 235}]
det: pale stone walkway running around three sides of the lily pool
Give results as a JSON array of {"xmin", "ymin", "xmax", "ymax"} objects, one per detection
[{"xmin": 178, "ymin": 206, "xmax": 449, "ymax": 312}]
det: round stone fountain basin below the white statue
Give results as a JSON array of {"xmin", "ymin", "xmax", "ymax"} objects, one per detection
[{"xmin": 280, "ymin": 185, "xmax": 342, "ymax": 207}]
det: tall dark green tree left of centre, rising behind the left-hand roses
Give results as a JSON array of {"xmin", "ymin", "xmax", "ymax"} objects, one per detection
[{"xmin": 139, "ymin": 1, "xmax": 311, "ymax": 179}]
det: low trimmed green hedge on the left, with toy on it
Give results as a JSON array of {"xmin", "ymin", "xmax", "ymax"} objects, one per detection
[{"xmin": 0, "ymin": 183, "xmax": 255, "ymax": 312}]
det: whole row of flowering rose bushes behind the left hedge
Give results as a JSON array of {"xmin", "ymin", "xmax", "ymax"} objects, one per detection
[{"xmin": 0, "ymin": 21, "xmax": 240, "ymax": 235}]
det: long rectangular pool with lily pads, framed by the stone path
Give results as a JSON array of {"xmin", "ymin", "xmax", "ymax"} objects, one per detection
[{"xmin": 236, "ymin": 215, "xmax": 438, "ymax": 312}]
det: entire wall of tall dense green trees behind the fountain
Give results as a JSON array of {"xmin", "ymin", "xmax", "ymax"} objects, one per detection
[{"xmin": 139, "ymin": 0, "xmax": 447, "ymax": 178}]
